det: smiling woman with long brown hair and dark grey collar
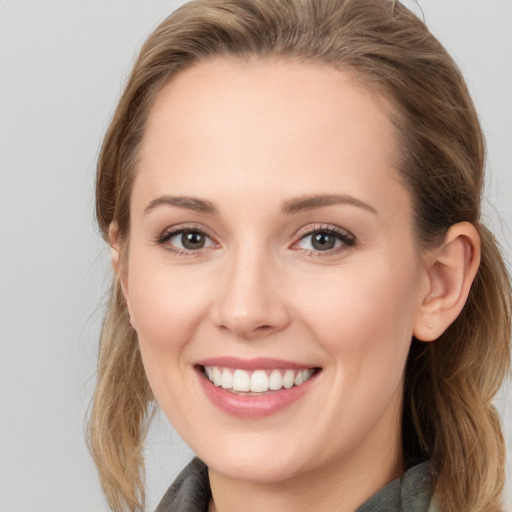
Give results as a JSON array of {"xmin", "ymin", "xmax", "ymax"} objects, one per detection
[{"xmin": 89, "ymin": 0, "xmax": 510, "ymax": 512}]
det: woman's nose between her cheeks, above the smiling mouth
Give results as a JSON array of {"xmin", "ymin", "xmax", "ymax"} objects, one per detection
[{"xmin": 212, "ymin": 245, "xmax": 290, "ymax": 340}]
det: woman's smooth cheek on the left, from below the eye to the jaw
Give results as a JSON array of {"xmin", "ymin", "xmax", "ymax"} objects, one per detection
[{"xmin": 128, "ymin": 251, "xmax": 215, "ymax": 420}]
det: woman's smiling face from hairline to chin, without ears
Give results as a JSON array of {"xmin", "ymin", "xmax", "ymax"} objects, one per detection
[{"xmin": 123, "ymin": 59, "xmax": 429, "ymax": 482}]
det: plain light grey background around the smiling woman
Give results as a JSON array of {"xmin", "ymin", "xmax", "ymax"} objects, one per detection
[{"xmin": 0, "ymin": 0, "xmax": 512, "ymax": 512}]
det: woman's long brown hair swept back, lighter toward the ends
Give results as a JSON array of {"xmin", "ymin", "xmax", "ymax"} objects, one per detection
[{"xmin": 89, "ymin": 0, "xmax": 511, "ymax": 512}]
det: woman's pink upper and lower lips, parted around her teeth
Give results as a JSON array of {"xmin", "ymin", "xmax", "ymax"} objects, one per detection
[{"xmin": 195, "ymin": 358, "xmax": 318, "ymax": 418}]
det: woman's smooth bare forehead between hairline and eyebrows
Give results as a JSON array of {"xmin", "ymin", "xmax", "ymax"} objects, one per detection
[{"xmin": 134, "ymin": 58, "xmax": 410, "ymax": 218}]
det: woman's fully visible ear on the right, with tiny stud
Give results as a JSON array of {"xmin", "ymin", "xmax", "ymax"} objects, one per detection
[{"xmin": 413, "ymin": 222, "xmax": 480, "ymax": 341}]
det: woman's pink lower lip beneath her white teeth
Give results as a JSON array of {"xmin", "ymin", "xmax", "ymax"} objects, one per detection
[{"xmin": 197, "ymin": 369, "xmax": 318, "ymax": 418}]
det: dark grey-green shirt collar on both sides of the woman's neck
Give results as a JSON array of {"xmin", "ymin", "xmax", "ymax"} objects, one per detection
[{"xmin": 155, "ymin": 458, "xmax": 437, "ymax": 512}]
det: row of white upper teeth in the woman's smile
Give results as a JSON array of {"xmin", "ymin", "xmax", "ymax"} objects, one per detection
[{"xmin": 204, "ymin": 366, "xmax": 314, "ymax": 393}]
